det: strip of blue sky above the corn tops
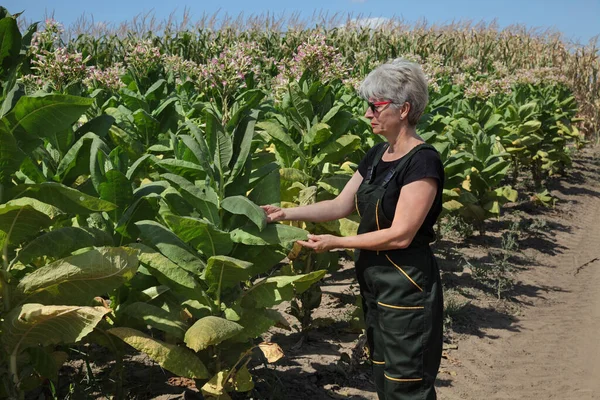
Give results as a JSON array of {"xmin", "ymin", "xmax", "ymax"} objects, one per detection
[{"xmin": 3, "ymin": 0, "xmax": 600, "ymax": 44}]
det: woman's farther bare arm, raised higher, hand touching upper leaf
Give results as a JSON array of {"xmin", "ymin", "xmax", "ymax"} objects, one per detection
[{"xmin": 262, "ymin": 171, "xmax": 363, "ymax": 222}]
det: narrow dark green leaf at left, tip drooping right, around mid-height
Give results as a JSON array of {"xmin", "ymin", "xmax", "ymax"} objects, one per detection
[{"xmin": 11, "ymin": 182, "xmax": 116, "ymax": 215}]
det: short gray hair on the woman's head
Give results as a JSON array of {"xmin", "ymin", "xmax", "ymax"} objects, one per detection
[{"xmin": 358, "ymin": 58, "xmax": 429, "ymax": 126}]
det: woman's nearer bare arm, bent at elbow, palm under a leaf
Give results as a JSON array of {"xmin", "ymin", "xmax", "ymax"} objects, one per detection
[{"xmin": 298, "ymin": 178, "xmax": 438, "ymax": 252}]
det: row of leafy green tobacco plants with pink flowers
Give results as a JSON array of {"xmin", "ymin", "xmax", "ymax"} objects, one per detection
[{"xmin": 0, "ymin": 9, "xmax": 584, "ymax": 398}]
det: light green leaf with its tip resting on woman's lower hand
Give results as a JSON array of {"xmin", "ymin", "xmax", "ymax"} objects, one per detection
[{"xmin": 231, "ymin": 224, "xmax": 308, "ymax": 246}]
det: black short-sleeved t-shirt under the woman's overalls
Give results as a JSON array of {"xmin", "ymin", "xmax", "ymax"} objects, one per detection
[{"xmin": 358, "ymin": 143, "xmax": 444, "ymax": 247}]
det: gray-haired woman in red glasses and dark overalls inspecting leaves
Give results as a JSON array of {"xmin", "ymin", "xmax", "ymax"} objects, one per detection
[{"xmin": 263, "ymin": 59, "xmax": 444, "ymax": 400}]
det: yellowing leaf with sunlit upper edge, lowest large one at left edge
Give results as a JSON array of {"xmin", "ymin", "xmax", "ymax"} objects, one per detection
[{"xmin": 2, "ymin": 304, "xmax": 111, "ymax": 355}]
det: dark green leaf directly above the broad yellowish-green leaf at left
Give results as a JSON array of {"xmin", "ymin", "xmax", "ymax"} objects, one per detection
[{"xmin": 15, "ymin": 226, "xmax": 113, "ymax": 264}]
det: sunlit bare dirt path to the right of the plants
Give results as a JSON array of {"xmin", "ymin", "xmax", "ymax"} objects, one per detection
[{"xmin": 438, "ymin": 153, "xmax": 600, "ymax": 400}]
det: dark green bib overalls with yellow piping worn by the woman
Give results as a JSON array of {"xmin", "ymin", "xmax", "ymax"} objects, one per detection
[{"xmin": 355, "ymin": 144, "xmax": 443, "ymax": 400}]
